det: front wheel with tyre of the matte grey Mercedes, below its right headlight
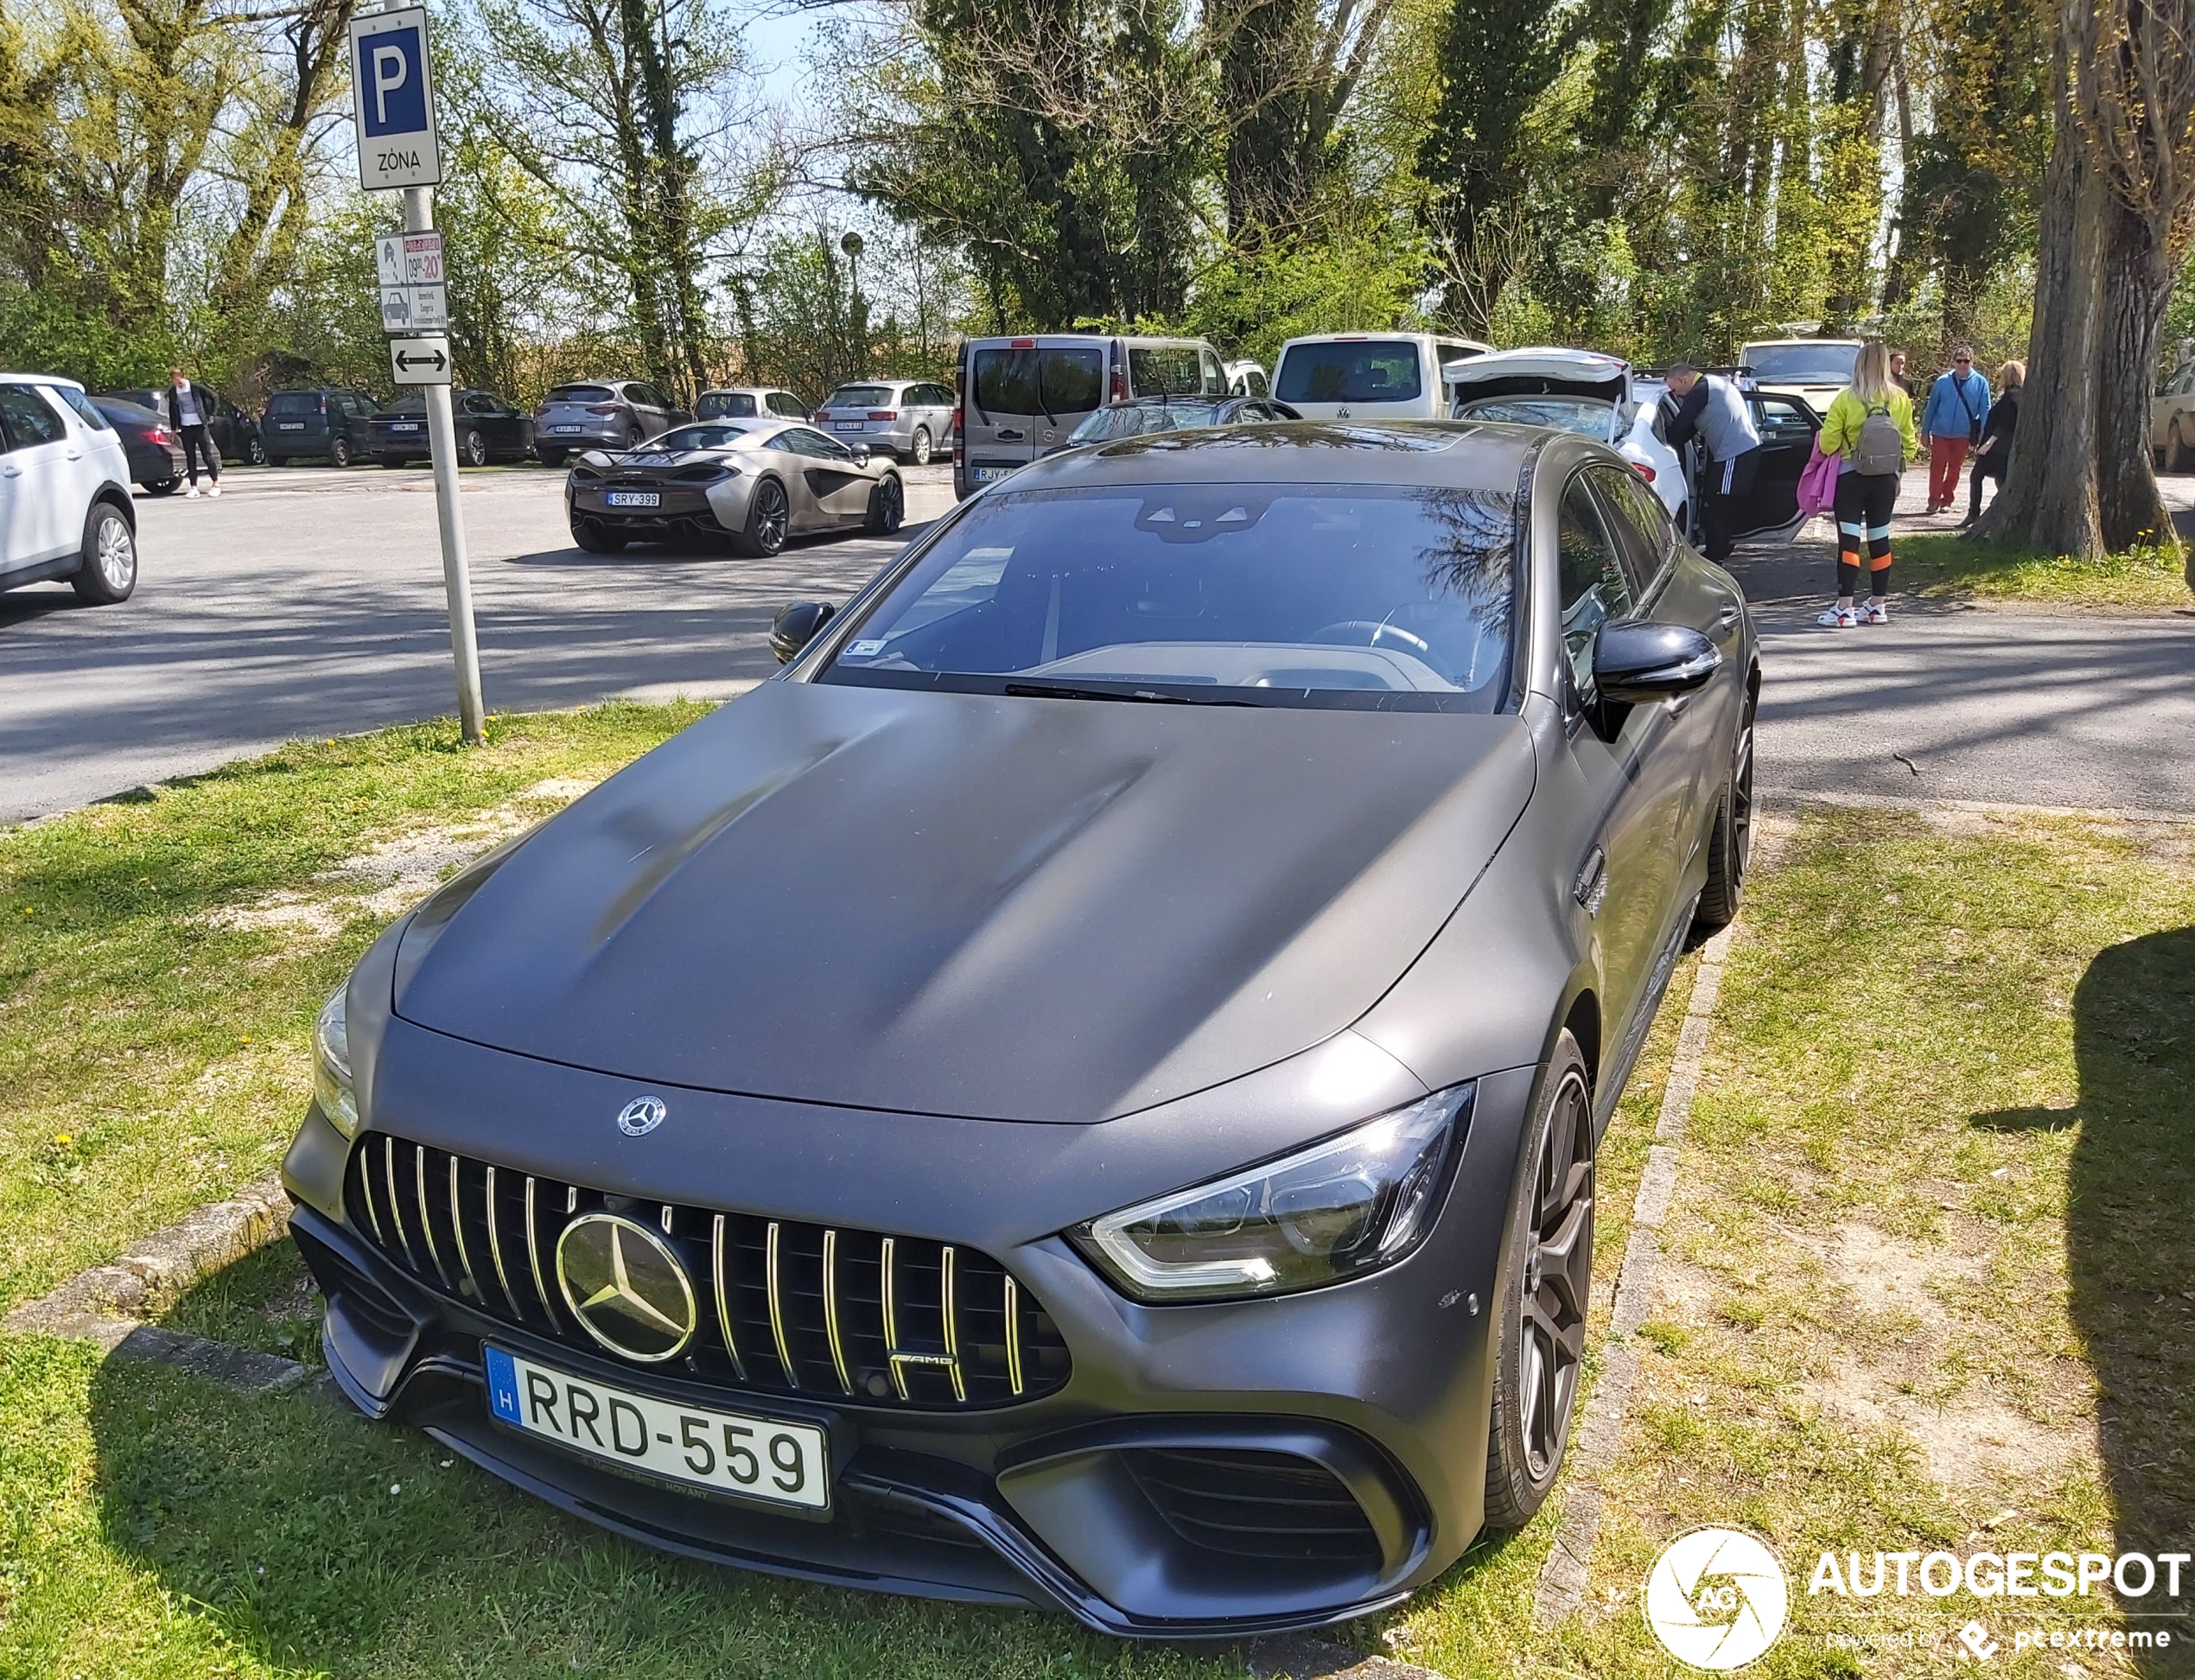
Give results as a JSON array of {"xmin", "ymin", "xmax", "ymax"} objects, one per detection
[{"xmin": 1486, "ymin": 1030, "xmax": 1594, "ymax": 1529}]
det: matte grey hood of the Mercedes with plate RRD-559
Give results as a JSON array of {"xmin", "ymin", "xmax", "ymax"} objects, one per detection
[{"xmin": 395, "ymin": 681, "xmax": 1534, "ymax": 1123}]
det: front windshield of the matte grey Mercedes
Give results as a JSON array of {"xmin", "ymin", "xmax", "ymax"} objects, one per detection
[{"xmin": 818, "ymin": 483, "xmax": 1517, "ymax": 711}]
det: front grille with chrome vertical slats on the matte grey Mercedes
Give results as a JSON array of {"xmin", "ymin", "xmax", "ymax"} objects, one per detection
[{"xmin": 345, "ymin": 1133, "xmax": 1066, "ymax": 1408}]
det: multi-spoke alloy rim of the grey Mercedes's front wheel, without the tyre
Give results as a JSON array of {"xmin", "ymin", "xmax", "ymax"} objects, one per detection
[{"xmin": 1517, "ymin": 1067, "xmax": 1594, "ymax": 1482}]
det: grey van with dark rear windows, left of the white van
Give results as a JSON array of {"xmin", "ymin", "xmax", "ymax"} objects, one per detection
[{"xmin": 952, "ymin": 332, "xmax": 1227, "ymax": 499}]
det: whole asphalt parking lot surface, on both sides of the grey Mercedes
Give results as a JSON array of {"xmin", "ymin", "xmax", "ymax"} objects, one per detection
[{"xmin": 0, "ymin": 466, "xmax": 2195, "ymax": 821}]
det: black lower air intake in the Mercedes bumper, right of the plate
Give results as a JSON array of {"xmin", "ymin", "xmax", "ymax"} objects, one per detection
[{"xmin": 1122, "ymin": 1448, "xmax": 1381, "ymax": 1563}]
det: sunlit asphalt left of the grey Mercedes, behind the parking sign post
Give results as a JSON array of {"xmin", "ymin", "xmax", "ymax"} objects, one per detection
[{"xmin": 0, "ymin": 466, "xmax": 952, "ymax": 821}]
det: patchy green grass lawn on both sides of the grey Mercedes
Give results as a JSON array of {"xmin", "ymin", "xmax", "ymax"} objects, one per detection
[{"xmin": 0, "ymin": 707, "xmax": 2195, "ymax": 1680}]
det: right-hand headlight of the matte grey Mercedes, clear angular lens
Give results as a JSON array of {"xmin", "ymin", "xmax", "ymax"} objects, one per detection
[{"xmin": 1073, "ymin": 1085, "xmax": 1471, "ymax": 1300}]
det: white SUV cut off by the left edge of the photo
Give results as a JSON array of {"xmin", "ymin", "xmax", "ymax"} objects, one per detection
[{"xmin": 0, "ymin": 373, "xmax": 136, "ymax": 601}]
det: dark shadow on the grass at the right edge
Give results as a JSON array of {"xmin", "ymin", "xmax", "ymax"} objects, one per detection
[{"xmin": 1971, "ymin": 926, "xmax": 2195, "ymax": 1676}]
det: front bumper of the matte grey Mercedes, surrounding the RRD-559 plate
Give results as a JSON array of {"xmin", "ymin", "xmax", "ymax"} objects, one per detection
[{"xmin": 285, "ymin": 1028, "xmax": 1530, "ymax": 1639}]
